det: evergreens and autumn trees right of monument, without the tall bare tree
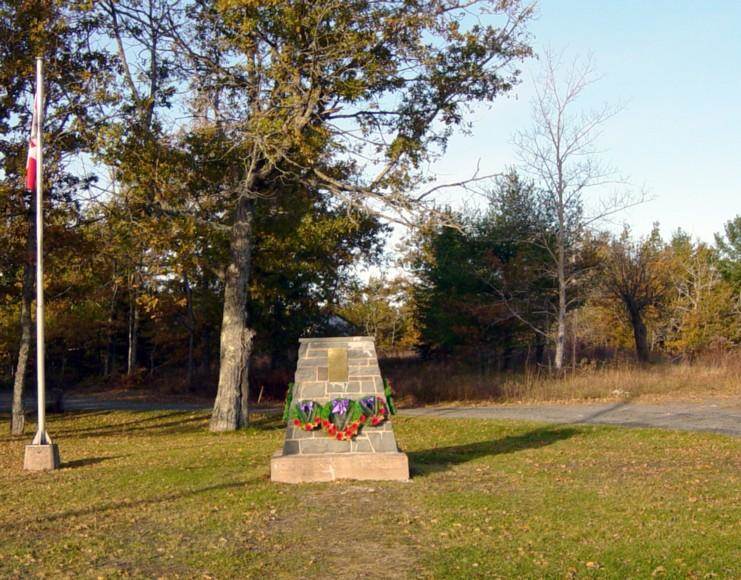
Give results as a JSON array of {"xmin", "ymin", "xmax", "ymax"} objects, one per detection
[{"xmin": 409, "ymin": 171, "xmax": 741, "ymax": 369}]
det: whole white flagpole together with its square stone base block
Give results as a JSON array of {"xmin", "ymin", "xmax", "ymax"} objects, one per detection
[{"xmin": 24, "ymin": 57, "xmax": 59, "ymax": 471}]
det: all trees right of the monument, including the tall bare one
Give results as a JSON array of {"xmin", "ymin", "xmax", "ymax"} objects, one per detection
[{"xmin": 348, "ymin": 52, "xmax": 741, "ymax": 372}]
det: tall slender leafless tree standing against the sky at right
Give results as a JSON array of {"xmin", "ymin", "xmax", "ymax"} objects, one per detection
[{"xmin": 514, "ymin": 51, "xmax": 640, "ymax": 370}]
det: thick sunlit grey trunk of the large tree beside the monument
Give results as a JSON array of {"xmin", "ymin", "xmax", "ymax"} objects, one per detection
[{"xmin": 210, "ymin": 195, "xmax": 254, "ymax": 431}]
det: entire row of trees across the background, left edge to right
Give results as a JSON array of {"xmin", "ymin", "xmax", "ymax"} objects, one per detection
[{"xmin": 0, "ymin": 0, "xmax": 741, "ymax": 433}]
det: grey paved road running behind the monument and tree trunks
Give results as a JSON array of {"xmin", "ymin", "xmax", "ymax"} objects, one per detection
[{"xmin": 0, "ymin": 393, "xmax": 741, "ymax": 436}]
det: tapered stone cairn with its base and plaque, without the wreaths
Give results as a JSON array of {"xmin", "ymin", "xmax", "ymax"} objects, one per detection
[{"xmin": 270, "ymin": 336, "xmax": 409, "ymax": 483}]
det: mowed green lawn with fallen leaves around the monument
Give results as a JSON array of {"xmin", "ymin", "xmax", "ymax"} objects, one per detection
[{"xmin": 0, "ymin": 412, "xmax": 741, "ymax": 578}]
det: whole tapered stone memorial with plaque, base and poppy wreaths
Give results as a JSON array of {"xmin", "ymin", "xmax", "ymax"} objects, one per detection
[{"xmin": 270, "ymin": 336, "xmax": 409, "ymax": 483}]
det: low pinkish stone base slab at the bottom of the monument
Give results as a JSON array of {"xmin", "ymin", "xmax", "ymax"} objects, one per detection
[{"xmin": 270, "ymin": 451, "xmax": 409, "ymax": 483}]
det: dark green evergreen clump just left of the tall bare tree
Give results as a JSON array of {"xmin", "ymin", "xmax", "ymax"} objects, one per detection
[{"xmin": 412, "ymin": 171, "xmax": 556, "ymax": 366}]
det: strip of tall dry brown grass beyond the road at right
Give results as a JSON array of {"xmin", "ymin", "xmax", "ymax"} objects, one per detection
[{"xmin": 384, "ymin": 353, "xmax": 741, "ymax": 404}]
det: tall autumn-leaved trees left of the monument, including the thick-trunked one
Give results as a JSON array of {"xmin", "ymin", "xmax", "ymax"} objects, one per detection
[{"xmin": 0, "ymin": 0, "xmax": 532, "ymax": 432}]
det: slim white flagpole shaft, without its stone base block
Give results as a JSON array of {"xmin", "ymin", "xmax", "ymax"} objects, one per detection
[{"xmin": 33, "ymin": 57, "xmax": 52, "ymax": 445}]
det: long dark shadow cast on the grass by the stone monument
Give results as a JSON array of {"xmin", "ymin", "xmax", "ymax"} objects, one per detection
[{"xmin": 408, "ymin": 427, "xmax": 583, "ymax": 476}]
